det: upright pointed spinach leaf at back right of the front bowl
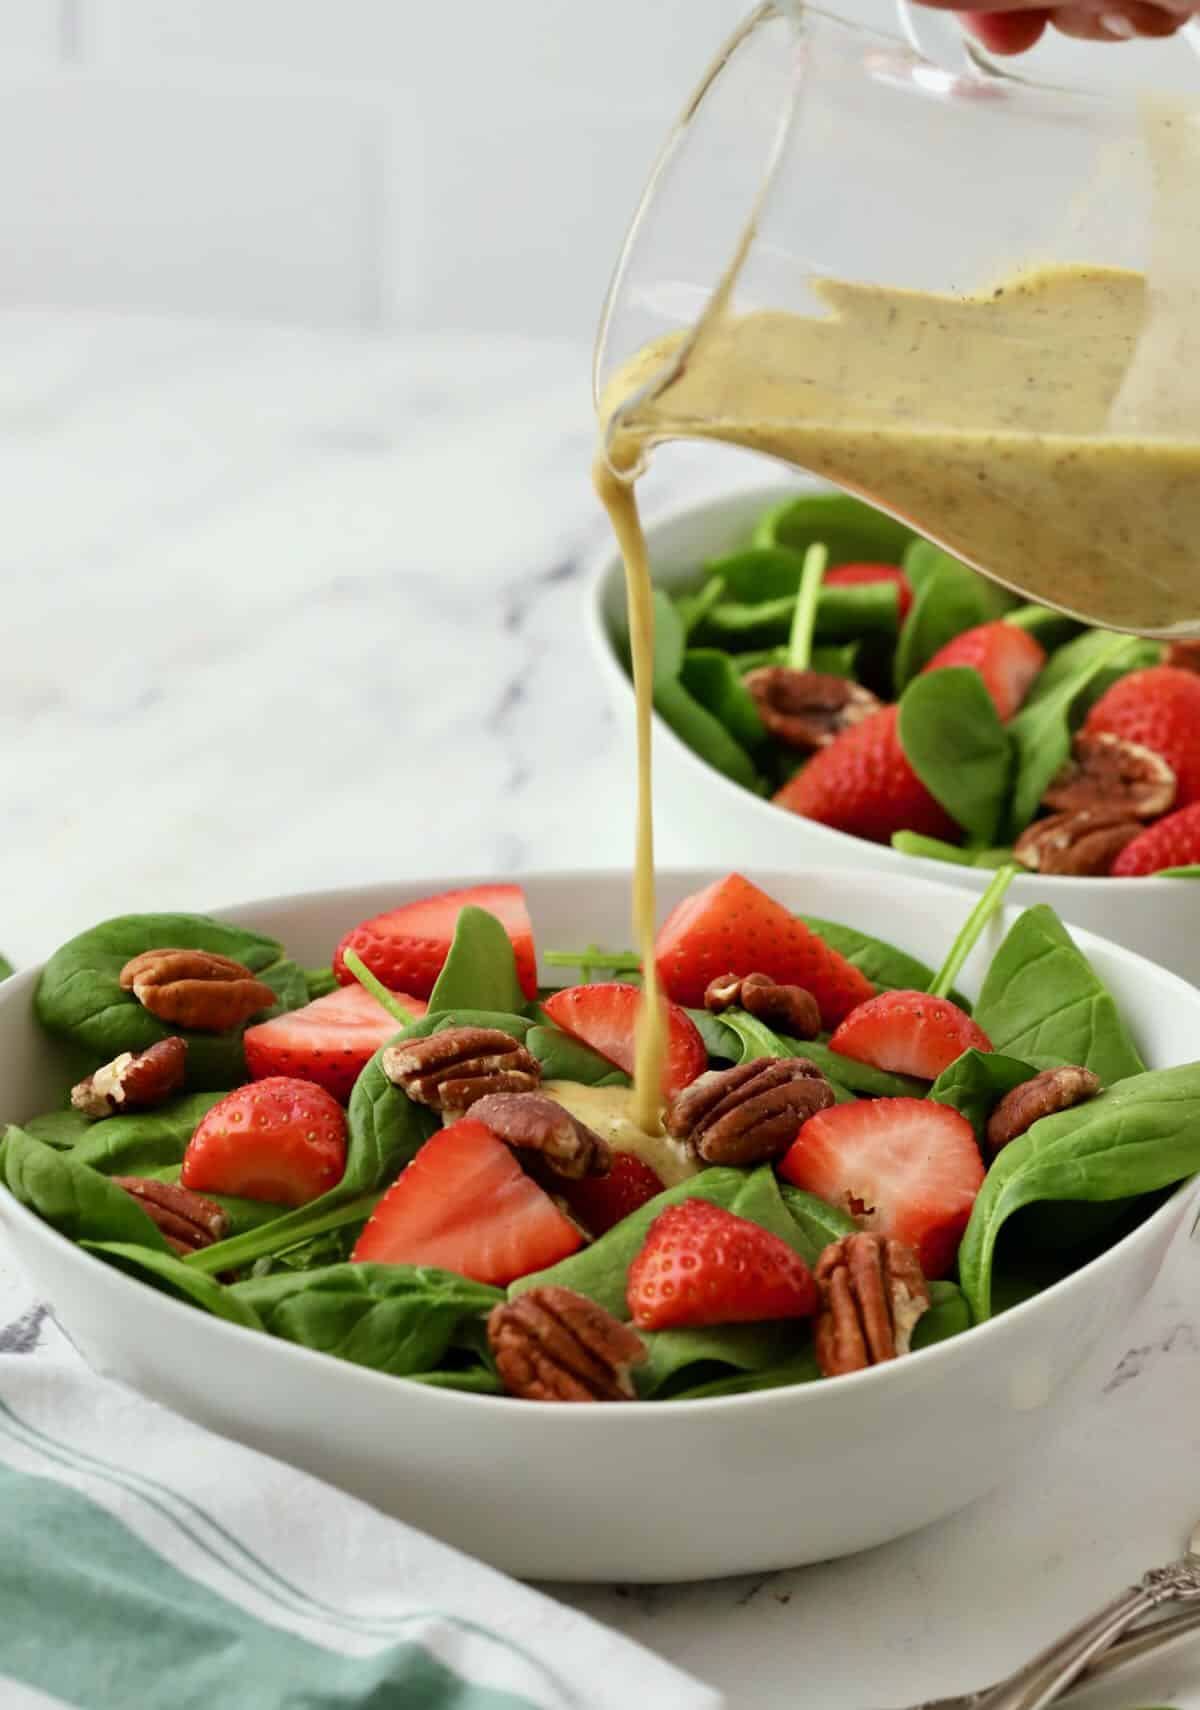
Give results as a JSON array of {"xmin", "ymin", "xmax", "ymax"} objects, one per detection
[{"xmin": 974, "ymin": 903, "xmax": 1145, "ymax": 1080}]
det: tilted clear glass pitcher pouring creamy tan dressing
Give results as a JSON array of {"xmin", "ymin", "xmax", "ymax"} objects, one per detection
[{"xmin": 595, "ymin": 0, "xmax": 1200, "ymax": 636}]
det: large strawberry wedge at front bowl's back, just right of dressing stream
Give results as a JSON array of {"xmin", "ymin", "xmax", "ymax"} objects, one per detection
[{"xmin": 655, "ymin": 872, "xmax": 875, "ymax": 1028}]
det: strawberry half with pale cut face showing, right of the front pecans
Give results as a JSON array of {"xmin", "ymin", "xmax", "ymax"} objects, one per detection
[{"xmin": 779, "ymin": 1098, "xmax": 983, "ymax": 1277}]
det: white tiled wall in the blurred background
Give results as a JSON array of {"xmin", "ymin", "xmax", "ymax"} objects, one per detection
[{"xmin": 0, "ymin": 0, "xmax": 1200, "ymax": 340}]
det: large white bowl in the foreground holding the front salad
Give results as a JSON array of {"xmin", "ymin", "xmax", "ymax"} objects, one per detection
[{"xmin": 0, "ymin": 872, "xmax": 1200, "ymax": 1580}]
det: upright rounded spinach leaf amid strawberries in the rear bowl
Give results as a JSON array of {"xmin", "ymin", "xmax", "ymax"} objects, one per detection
[{"xmin": 897, "ymin": 667, "xmax": 1012, "ymax": 843}]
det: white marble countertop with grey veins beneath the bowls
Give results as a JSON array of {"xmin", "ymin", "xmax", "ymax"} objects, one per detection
[{"xmin": 0, "ymin": 311, "xmax": 1200, "ymax": 1710}]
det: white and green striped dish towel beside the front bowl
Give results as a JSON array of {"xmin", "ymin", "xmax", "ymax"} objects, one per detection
[{"xmin": 0, "ymin": 1349, "xmax": 721, "ymax": 1710}]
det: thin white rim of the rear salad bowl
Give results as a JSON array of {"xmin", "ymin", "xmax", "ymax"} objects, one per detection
[{"xmin": 585, "ymin": 477, "xmax": 1200, "ymax": 918}]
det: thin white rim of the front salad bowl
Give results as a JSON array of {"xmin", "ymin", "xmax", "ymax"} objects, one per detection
[{"xmin": 0, "ymin": 865, "xmax": 1200, "ymax": 1430}]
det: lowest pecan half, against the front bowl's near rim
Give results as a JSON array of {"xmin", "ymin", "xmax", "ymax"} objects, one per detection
[{"xmin": 487, "ymin": 1288, "xmax": 646, "ymax": 1400}]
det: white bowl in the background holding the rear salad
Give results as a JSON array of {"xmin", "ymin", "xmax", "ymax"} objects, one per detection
[{"xmin": 588, "ymin": 481, "xmax": 1200, "ymax": 982}]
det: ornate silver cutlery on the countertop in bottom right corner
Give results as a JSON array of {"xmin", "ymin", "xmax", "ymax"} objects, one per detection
[{"xmin": 909, "ymin": 1520, "xmax": 1200, "ymax": 1710}]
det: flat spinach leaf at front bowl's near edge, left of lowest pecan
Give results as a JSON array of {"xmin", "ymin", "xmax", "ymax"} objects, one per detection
[{"xmin": 229, "ymin": 1264, "xmax": 504, "ymax": 1377}]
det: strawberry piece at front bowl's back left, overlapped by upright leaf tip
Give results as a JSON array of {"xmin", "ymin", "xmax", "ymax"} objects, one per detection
[{"xmin": 333, "ymin": 884, "xmax": 537, "ymax": 997}]
